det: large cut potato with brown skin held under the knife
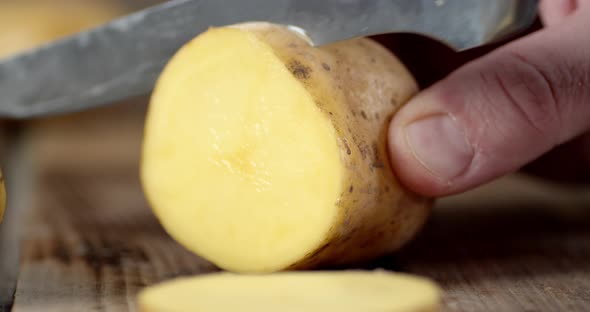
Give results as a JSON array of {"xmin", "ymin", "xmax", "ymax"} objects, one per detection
[{"xmin": 141, "ymin": 23, "xmax": 432, "ymax": 272}]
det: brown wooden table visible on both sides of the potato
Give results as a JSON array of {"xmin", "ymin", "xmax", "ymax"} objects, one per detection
[{"xmin": 0, "ymin": 99, "xmax": 590, "ymax": 312}]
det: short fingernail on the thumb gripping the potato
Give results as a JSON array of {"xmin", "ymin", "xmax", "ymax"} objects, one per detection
[{"xmin": 405, "ymin": 114, "xmax": 473, "ymax": 182}]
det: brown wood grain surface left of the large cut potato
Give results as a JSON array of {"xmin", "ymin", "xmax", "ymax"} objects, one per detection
[{"xmin": 8, "ymin": 101, "xmax": 216, "ymax": 312}]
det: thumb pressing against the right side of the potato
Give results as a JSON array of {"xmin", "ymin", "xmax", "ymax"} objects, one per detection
[{"xmin": 389, "ymin": 1, "xmax": 590, "ymax": 196}]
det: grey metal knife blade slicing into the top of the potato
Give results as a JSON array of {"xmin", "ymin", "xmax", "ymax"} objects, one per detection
[{"xmin": 0, "ymin": 0, "xmax": 537, "ymax": 118}]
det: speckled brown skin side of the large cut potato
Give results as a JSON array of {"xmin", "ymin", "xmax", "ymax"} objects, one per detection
[{"xmin": 235, "ymin": 23, "xmax": 433, "ymax": 269}]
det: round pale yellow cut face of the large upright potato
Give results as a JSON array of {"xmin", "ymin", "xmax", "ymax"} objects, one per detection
[{"xmin": 142, "ymin": 28, "xmax": 344, "ymax": 271}]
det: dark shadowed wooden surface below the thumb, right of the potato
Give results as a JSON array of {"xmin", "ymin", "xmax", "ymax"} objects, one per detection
[{"xmin": 396, "ymin": 176, "xmax": 590, "ymax": 311}]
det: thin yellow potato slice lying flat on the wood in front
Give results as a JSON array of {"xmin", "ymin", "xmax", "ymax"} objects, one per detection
[{"xmin": 138, "ymin": 271, "xmax": 440, "ymax": 312}]
